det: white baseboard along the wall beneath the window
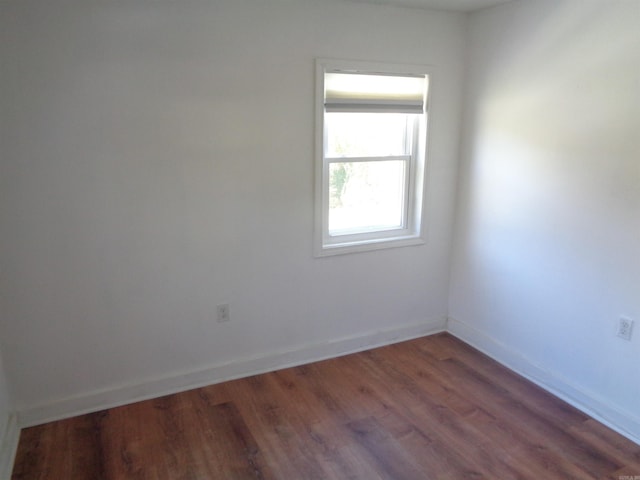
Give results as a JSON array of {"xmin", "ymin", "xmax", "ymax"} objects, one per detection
[{"xmin": 16, "ymin": 318, "xmax": 446, "ymax": 428}]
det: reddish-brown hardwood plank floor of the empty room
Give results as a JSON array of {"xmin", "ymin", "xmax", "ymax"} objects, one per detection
[{"xmin": 12, "ymin": 334, "xmax": 640, "ymax": 480}]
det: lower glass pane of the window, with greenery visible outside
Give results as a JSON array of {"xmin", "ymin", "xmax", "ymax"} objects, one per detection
[{"xmin": 329, "ymin": 160, "xmax": 405, "ymax": 235}]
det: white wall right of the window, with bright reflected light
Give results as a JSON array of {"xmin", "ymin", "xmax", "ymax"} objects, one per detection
[{"xmin": 450, "ymin": 0, "xmax": 640, "ymax": 439}]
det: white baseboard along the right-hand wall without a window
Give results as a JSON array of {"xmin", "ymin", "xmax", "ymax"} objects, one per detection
[{"xmin": 447, "ymin": 318, "xmax": 640, "ymax": 445}]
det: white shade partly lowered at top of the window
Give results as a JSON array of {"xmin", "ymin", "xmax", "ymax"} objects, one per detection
[{"xmin": 324, "ymin": 72, "xmax": 427, "ymax": 113}]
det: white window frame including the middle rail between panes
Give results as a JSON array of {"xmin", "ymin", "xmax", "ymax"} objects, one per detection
[{"xmin": 314, "ymin": 59, "xmax": 433, "ymax": 257}]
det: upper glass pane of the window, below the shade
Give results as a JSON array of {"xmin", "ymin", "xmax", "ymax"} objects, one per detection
[{"xmin": 325, "ymin": 112, "xmax": 415, "ymax": 158}]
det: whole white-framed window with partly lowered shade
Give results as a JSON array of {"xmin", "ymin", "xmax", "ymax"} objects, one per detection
[{"xmin": 316, "ymin": 60, "xmax": 428, "ymax": 256}]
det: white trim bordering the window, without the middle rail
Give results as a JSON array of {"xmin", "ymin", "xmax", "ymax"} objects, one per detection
[{"xmin": 314, "ymin": 59, "xmax": 433, "ymax": 257}]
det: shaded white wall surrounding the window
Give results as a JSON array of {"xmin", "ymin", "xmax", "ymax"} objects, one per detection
[{"xmin": 0, "ymin": 0, "xmax": 465, "ymax": 423}]
